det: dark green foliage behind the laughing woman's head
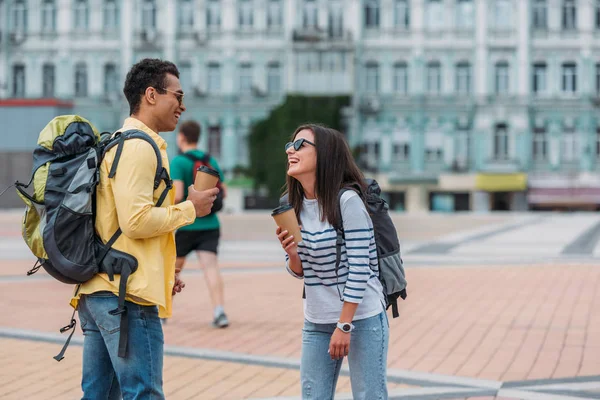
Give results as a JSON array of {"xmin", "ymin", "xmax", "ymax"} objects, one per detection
[{"xmin": 249, "ymin": 96, "xmax": 350, "ymax": 199}]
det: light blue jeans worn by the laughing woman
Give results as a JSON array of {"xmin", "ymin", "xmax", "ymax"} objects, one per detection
[{"xmin": 300, "ymin": 312, "xmax": 389, "ymax": 400}]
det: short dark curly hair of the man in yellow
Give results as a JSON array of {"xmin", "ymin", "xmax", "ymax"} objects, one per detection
[{"xmin": 123, "ymin": 58, "xmax": 179, "ymax": 115}]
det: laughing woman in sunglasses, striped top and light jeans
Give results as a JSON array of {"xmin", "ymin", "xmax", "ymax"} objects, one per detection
[{"xmin": 277, "ymin": 125, "xmax": 389, "ymax": 400}]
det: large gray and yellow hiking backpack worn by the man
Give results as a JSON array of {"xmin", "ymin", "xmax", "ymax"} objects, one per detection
[{"xmin": 15, "ymin": 115, "xmax": 172, "ymax": 361}]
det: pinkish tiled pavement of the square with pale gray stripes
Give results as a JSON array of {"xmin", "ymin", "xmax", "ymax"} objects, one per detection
[{"xmin": 0, "ymin": 214, "xmax": 600, "ymax": 399}]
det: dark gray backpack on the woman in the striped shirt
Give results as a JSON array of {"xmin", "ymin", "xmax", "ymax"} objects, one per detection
[{"xmin": 334, "ymin": 179, "xmax": 407, "ymax": 318}]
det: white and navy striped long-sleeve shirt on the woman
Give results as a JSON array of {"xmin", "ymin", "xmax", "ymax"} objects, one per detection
[{"xmin": 286, "ymin": 191, "xmax": 383, "ymax": 324}]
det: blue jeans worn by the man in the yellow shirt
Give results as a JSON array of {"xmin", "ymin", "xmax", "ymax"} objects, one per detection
[{"xmin": 79, "ymin": 292, "xmax": 165, "ymax": 400}]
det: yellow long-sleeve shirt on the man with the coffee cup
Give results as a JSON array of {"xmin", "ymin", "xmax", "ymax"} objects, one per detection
[{"xmin": 71, "ymin": 118, "xmax": 196, "ymax": 318}]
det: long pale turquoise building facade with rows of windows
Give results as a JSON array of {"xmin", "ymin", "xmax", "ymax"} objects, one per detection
[{"xmin": 0, "ymin": 0, "xmax": 600, "ymax": 211}]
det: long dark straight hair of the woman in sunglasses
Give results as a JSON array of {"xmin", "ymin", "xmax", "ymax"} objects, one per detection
[{"xmin": 286, "ymin": 124, "xmax": 367, "ymax": 226}]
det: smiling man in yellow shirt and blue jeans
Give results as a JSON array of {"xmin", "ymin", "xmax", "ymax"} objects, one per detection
[{"xmin": 71, "ymin": 59, "xmax": 218, "ymax": 399}]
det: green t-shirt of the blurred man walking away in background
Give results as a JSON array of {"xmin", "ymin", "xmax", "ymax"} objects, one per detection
[{"xmin": 171, "ymin": 150, "xmax": 223, "ymax": 231}]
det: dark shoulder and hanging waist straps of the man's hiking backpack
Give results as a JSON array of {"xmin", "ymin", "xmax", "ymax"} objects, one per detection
[{"xmin": 98, "ymin": 130, "xmax": 173, "ymax": 358}]
